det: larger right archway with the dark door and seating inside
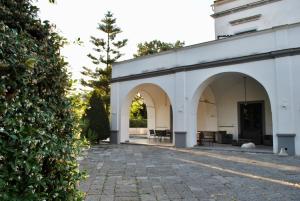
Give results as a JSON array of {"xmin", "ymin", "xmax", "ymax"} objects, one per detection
[{"xmin": 194, "ymin": 72, "xmax": 274, "ymax": 150}]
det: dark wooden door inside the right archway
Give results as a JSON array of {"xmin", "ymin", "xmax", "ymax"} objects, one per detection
[{"xmin": 239, "ymin": 102, "xmax": 264, "ymax": 145}]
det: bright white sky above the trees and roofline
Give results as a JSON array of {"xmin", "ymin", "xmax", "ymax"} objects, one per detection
[{"xmin": 37, "ymin": 0, "xmax": 214, "ymax": 79}]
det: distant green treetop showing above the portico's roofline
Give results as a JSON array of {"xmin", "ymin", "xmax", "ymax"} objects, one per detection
[{"xmin": 133, "ymin": 40, "xmax": 184, "ymax": 57}]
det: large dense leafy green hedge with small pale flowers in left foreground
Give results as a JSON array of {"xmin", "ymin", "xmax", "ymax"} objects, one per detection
[{"xmin": 0, "ymin": 0, "xmax": 82, "ymax": 201}]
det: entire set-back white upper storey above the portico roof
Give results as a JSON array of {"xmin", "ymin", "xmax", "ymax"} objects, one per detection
[{"xmin": 211, "ymin": 0, "xmax": 300, "ymax": 39}]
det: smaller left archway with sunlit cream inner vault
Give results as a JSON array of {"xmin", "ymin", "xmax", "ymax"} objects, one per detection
[{"xmin": 120, "ymin": 83, "xmax": 173, "ymax": 142}]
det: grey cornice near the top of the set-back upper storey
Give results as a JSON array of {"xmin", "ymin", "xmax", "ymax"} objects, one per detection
[{"xmin": 211, "ymin": 0, "xmax": 282, "ymax": 18}]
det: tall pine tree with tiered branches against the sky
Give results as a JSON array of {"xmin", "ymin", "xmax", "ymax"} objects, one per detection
[{"xmin": 81, "ymin": 11, "xmax": 127, "ymax": 113}]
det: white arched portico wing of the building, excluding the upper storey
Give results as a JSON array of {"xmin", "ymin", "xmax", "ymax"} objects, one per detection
[{"xmin": 111, "ymin": 23, "xmax": 300, "ymax": 155}]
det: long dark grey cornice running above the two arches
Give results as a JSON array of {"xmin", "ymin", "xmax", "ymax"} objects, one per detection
[{"xmin": 111, "ymin": 47, "xmax": 300, "ymax": 83}]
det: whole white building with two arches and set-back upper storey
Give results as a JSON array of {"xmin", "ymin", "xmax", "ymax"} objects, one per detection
[{"xmin": 111, "ymin": 0, "xmax": 300, "ymax": 155}]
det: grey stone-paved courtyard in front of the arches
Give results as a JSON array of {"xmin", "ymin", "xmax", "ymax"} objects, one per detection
[{"xmin": 80, "ymin": 145, "xmax": 300, "ymax": 201}]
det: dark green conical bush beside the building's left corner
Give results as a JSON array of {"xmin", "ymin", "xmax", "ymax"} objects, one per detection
[{"xmin": 83, "ymin": 90, "xmax": 110, "ymax": 143}]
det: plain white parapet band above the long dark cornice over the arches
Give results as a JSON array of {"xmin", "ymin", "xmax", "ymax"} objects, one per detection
[{"xmin": 112, "ymin": 22, "xmax": 300, "ymax": 82}]
